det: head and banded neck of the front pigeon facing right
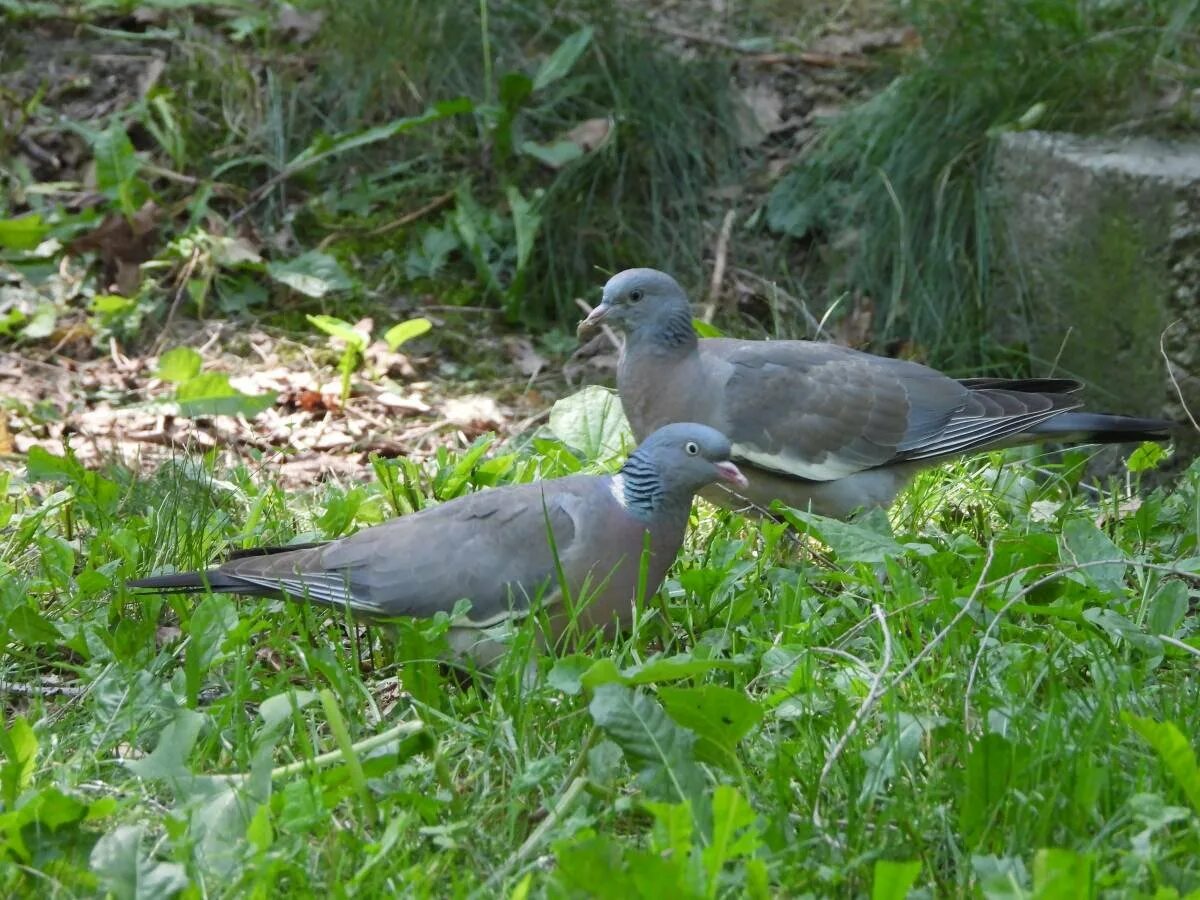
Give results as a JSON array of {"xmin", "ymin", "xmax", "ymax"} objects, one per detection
[{"xmin": 620, "ymin": 422, "xmax": 746, "ymax": 512}]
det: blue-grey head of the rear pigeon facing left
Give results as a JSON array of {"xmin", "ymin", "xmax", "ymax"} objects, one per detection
[{"xmin": 578, "ymin": 269, "xmax": 696, "ymax": 347}]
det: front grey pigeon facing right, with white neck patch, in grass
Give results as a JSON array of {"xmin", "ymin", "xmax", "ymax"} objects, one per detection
[{"xmin": 128, "ymin": 422, "xmax": 745, "ymax": 665}]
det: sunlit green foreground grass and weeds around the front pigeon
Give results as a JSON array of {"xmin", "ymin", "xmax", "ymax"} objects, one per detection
[{"xmin": 0, "ymin": 420, "xmax": 1200, "ymax": 898}]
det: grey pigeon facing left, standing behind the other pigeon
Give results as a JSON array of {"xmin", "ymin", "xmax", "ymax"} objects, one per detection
[{"xmin": 580, "ymin": 269, "xmax": 1172, "ymax": 518}]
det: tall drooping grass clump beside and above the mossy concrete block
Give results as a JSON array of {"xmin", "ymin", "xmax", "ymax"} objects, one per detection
[{"xmin": 768, "ymin": 0, "xmax": 1200, "ymax": 368}]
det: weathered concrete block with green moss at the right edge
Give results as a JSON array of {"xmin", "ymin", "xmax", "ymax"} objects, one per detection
[{"xmin": 990, "ymin": 131, "xmax": 1200, "ymax": 454}]
